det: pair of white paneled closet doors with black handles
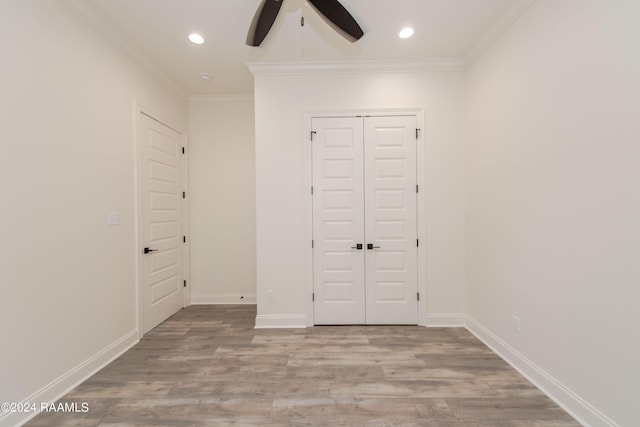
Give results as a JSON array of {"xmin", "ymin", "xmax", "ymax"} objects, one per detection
[{"xmin": 312, "ymin": 116, "xmax": 418, "ymax": 325}]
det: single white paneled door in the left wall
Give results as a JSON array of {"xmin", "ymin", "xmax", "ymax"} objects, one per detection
[{"xmin": 139, "ymin": 114, "xmax": 184, "ymax": 333}]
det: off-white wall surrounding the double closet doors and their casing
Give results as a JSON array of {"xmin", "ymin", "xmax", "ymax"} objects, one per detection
[{"xmin": 253, "ymin": 66, "xmax": 465, "ymax": 326}]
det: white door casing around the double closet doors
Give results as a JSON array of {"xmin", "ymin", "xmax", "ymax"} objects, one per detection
[{"xmin": 302, "ymin": 107, "xmax": 428, "ymax": 327}]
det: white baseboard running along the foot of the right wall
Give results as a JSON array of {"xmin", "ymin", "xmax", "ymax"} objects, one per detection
[{"xmin": 467, "ymin": 316, "xmax": 619, "ymax": 427}]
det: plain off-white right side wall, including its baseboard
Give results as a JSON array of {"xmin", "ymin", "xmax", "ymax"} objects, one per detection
[{"xmin": 466, "ymin": 0, "xmax": 640, "ymax": 426}]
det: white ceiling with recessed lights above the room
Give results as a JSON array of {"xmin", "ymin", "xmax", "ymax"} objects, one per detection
[{"xmin": 75, "ymin": 0, "xmax": 531, "ymax": 95}]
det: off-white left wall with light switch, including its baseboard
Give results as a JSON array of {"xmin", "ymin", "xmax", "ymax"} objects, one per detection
[{"xmin": 0, "ymin": 0, "xmax": 187, "ymax": 425}]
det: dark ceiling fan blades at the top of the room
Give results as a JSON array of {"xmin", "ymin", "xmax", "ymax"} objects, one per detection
[{"xmin": 247, "ymin": 0, "xmax": 364, "ymax": 46}]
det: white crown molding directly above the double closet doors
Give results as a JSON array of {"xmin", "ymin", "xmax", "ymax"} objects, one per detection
[{"xmin": 247, "ymin": 58, "xmax": 464, "ymax": 76}]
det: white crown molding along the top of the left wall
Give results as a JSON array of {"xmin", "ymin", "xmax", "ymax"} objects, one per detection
[{"xmin": 58, "ymin": 0, "xmax": 187, "ymax": 98}]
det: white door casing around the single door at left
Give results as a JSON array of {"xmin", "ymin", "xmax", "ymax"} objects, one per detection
[{"xmin": 133, "ymin": 101, "xmax": 191, "ymax": 339}]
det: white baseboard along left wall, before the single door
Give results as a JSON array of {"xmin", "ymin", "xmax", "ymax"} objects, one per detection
[{"xmin": 0, "ymin": 329, "xmax": 139, "ymax": 427}]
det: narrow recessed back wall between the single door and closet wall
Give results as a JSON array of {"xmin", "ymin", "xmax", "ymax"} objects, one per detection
[{"xmin": 189, "ymin": 97, "xmax": 256, "ymax": 304}]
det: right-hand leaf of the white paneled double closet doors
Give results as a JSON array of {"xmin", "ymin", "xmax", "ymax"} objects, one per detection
[{"xmin": 364, "ymin": 116, "xmax": 418, "ymax": 325}]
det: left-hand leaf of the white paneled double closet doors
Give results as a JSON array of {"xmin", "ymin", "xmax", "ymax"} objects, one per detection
[{"xmin": 312, "ymin": 117, "xmax": 365, "ymax": 325}]
